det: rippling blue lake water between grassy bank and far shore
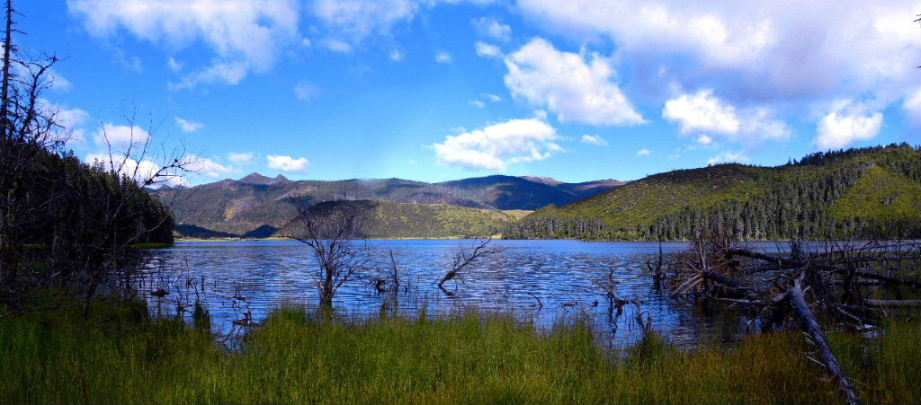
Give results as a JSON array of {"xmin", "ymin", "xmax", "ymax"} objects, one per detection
[{"xmin": 138, "ymin": 240, "xmax": 796, "ymax": 346}]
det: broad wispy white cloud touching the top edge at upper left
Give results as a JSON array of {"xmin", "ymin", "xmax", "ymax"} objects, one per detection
[{"xmin": 67, "ymin": 0, "xmax": 299, "ymax": 89}]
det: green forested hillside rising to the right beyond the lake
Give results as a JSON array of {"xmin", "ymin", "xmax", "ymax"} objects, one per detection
[{"xmin": 505, "ymin": 144, "xmax": 921, "ymax": 240}]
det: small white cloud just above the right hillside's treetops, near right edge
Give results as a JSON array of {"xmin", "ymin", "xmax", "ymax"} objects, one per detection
[{"xmin": 815, "ymin": 101, "xmax": 883, "ymax": 149}]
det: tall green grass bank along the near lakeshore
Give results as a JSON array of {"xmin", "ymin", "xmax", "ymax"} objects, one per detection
[{"xmin": 0, "ymin": 302, "xmax": 921, "ymax": 403}]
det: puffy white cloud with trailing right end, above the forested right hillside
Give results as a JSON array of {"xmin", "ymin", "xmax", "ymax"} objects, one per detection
[{"xmin": 662, "ymin": 89, "xmax": 791, "ymax": 145}]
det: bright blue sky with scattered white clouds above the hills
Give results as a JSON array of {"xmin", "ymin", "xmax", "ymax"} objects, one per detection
[{"xmin": 19, "ymin": 0, "xmax": 921, "ymax": 184}]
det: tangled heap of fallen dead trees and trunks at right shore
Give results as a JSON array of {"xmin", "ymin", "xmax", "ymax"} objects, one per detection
[{"xmin": 669, "ymin": 227, "xmax": 921, "ymax": 404}]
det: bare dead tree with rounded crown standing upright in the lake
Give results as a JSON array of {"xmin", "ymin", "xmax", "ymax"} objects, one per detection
[{"xmin": 288, "ymin": 202, "xmax": 368, "ymax": 307}]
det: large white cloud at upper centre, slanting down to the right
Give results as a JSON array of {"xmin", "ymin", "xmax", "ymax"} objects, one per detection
[{"xmin": 505, "ymin": 38, "xmax": 645, "ymax": 125}]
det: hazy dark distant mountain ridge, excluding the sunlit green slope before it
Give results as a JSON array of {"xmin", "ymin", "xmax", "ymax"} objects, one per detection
[{"xmin": 154, "ymin": 173, "xmax": 625, "ymax": 237}]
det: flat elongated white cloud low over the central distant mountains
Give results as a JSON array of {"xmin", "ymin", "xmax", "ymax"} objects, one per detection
[{"xmin": 432, "ymin": 118, "xmax": 563, "ymax": 172}]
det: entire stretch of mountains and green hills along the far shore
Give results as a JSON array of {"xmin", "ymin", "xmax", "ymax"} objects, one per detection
[{"xmin": 155, "ymin": 144, "xmax": 921, "ymax": 240}]
